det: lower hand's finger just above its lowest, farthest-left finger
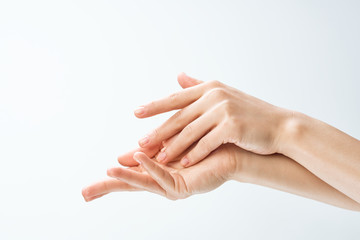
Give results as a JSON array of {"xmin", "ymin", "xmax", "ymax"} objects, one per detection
[{"xmin": 107, "ymin": 168, "xmax": 165, "ymax": 196}]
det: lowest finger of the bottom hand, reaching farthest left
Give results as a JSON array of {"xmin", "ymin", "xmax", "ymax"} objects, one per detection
[{"xmin": 82, "ymin": 179, "xmax": 140, "ymax": 201}]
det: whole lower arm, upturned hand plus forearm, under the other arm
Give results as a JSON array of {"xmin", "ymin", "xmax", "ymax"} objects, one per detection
[{"xmin": 83, "ymin": 136, "xmax": 360, "ymax": 211}]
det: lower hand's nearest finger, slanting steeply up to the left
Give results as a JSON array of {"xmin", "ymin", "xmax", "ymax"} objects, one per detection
[{"xmin": 134, "ymin": 152, "xmax": 175, "ymax": 191}]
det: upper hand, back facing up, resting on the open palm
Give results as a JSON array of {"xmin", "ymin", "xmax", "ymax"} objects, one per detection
[{"xmin": 135, "ymin": 74, "xmax": 292, "ymax": 166}]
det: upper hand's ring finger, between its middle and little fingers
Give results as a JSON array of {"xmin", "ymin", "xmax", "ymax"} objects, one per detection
[{"xmin": 156, "ymin": 111, "xmax": 219, "ymax": 163}]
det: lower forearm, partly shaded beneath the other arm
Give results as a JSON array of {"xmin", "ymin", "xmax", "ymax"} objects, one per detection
[{"xmin": 232, "ymin": 151, "xmax": 360, "ymax": 211}]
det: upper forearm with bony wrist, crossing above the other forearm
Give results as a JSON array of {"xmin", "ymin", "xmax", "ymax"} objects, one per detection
[{"xmin": 279, "ymin": 113, "xmax": 360, "ymax": 203}]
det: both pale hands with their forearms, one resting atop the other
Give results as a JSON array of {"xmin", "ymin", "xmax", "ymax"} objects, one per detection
[{"xmin": 83, "ymin": 74, "xmax": 360, "ymax": 211}]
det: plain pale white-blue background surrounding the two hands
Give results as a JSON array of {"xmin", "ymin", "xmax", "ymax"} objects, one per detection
[{"xmin": 0, "ymin": 0, "xmax": 360, "ymax": 239}]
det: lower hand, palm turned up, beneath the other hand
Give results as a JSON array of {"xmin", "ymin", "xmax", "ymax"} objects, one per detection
[{"xmin": 82, "ymin": 141, "xmax": 240, "ymax": 201}]
